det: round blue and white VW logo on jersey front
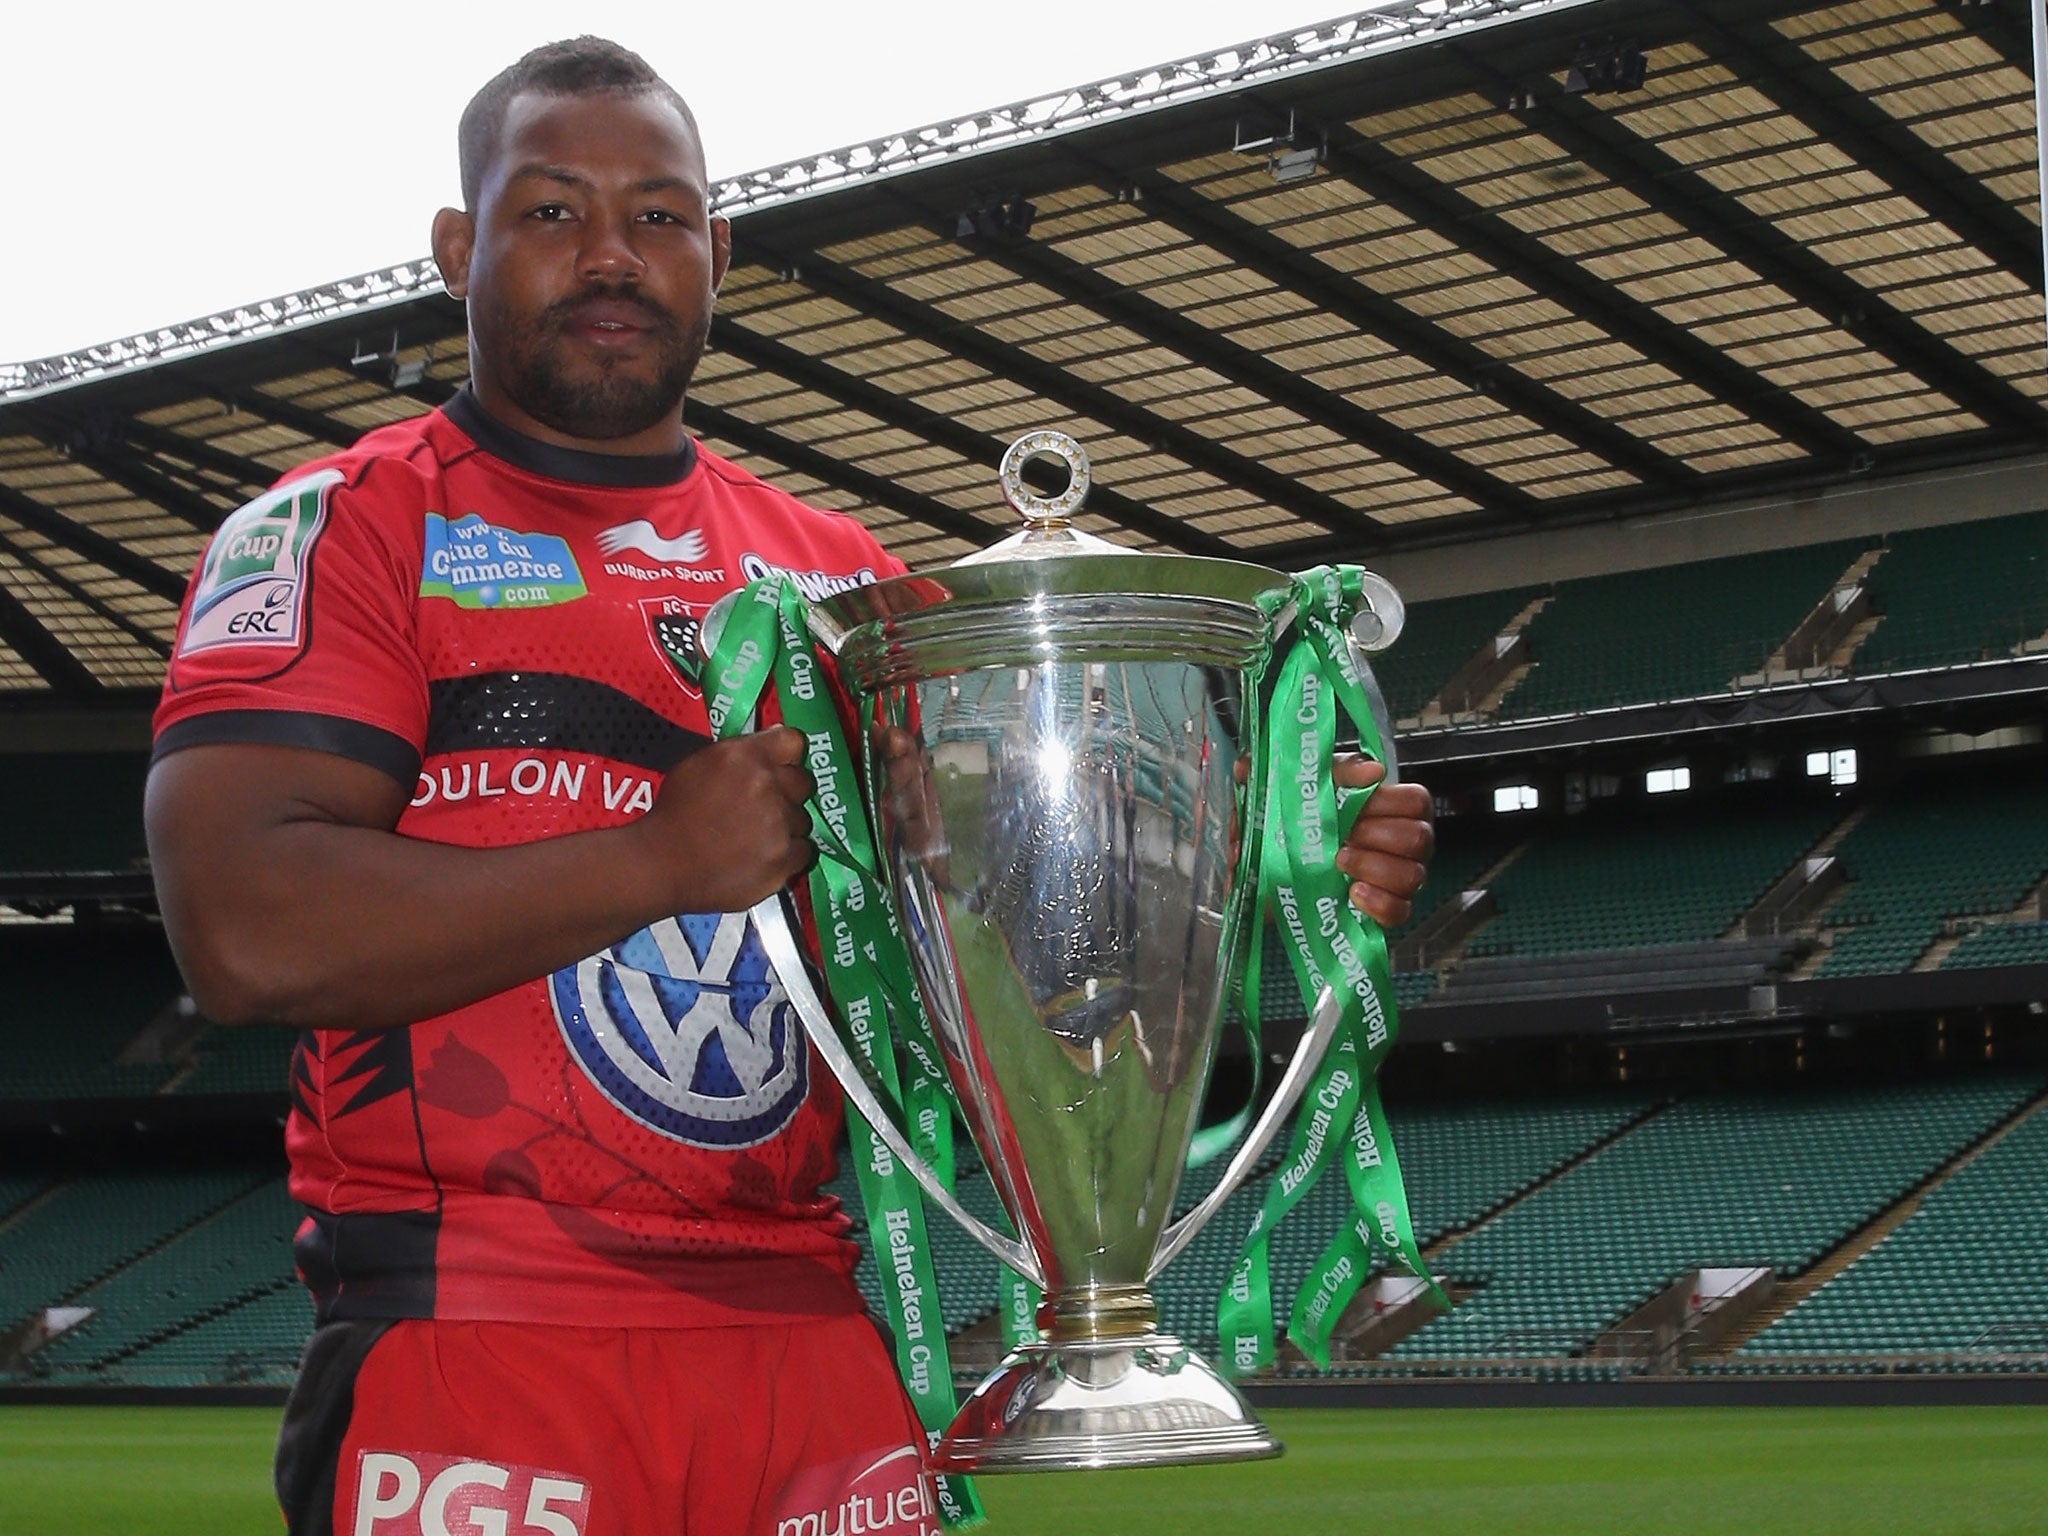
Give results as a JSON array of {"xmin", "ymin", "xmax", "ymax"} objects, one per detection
[{"xmin": 549, "ymin": 911, "xmax": 807, "ymax": 1151}]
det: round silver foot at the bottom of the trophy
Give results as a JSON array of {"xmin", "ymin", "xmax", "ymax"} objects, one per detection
[{"xmin": 932, "ymin": 1333, "xmax": 1282, "ymax": 1473}]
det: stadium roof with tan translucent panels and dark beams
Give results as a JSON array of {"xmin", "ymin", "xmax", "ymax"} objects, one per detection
[{"xmin": 0, "ymin": 0, "xmax": 2048, "ymax": 702}]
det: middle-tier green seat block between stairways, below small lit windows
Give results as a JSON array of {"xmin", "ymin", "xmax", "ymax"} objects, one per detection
[{"xmin": 1466, "ymin": 805, "xmax": 1835, "ymax": 956}]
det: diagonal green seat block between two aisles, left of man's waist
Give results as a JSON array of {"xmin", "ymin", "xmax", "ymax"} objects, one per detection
[{"xmin": 35, "ymin": 1180, "xmax": 301, "ymax": 1378}]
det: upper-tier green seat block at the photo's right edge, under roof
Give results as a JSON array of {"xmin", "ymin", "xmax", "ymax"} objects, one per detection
[{"xmin": 1853, "ymin": 512, "xmax": 2048, "ymax": 676}]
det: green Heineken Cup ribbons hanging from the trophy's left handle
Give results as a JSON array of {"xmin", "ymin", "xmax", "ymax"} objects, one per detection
[{"xmin": 702, "ymin": 578, "xmax": 985, "ymax": 1530}]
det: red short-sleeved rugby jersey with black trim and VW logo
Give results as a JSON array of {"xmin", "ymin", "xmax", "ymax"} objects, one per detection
[{"xmin": 156, "ymin": 391, "xmax": 903, "ymax": 1327}]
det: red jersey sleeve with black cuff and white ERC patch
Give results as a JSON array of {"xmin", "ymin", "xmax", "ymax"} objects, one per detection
[{"xmin": 154, "ymin": 459, "xmax": 428, "ymax": 786}]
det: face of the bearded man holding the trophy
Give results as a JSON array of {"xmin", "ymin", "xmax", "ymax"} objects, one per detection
[{"xmin": 442, "ymin": 90, "xmax": 729, "ymax": 442}]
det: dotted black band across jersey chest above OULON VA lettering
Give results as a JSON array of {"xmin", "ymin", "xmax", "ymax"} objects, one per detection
[{"xmin": 426, "ymin": 672, "xmax": 711, "ymax": 774}]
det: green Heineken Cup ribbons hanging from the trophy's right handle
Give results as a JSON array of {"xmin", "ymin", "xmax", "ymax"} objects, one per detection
[{"xmin": 1217, "ymin": 565, "xmax": 1442, "ymax": 1374}]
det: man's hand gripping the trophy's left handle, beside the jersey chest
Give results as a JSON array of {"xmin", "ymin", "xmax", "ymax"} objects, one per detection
[{"xmin": 627, "ymin": 725, "xmax": 817, "ymax": 913}]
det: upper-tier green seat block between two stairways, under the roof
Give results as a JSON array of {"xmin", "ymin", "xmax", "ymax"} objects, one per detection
[{"xmin": 1499, "ymin": 541, "xmax": 1864, "ymax": 719}]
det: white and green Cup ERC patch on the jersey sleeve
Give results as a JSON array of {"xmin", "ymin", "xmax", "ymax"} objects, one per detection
[{"xmin": 178, "ymin": 469, "xmax": 342, "ymax": 655}]
